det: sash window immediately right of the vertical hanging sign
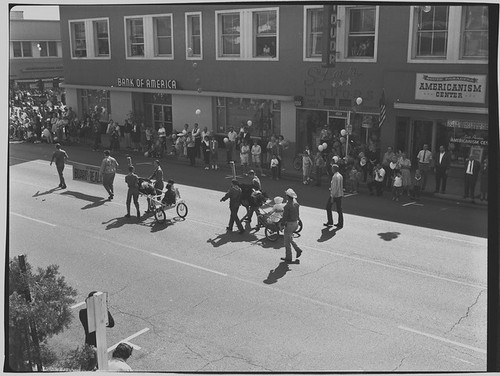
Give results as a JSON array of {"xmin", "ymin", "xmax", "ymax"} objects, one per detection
[{"xmin": 347, "ymin": 7, "xmax": 375, "ymax": 58}]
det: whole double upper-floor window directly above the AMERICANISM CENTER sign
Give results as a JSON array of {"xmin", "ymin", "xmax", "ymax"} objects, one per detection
[{"xmin": 408, "ymin": 5, "xmax": 489, "ymax": 64}]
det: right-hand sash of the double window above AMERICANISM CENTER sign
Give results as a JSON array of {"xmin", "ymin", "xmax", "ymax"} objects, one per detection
[{"xmin": 462, "ymin": 6, "xmax": 488, "ymax": 58}]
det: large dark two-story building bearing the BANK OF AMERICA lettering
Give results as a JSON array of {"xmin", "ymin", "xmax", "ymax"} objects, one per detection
[{"xmin": 60, "ymin": 3, "xmax": 492, "ymax": 170}]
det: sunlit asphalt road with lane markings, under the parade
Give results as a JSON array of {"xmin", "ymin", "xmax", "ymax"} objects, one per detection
[{"xmin": 9, "ymin": 145, "xmax": 487, "ymax": 372}]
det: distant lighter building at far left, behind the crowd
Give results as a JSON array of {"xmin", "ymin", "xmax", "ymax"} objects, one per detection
[{"xmin": 9, "ymin": 11, "xmax": 63, "ymax": 89}]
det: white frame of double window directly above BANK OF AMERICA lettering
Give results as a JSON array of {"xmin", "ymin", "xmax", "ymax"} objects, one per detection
[{"xmin": 123, "ymin": 13, "xmax": 175, "ymax": 60}]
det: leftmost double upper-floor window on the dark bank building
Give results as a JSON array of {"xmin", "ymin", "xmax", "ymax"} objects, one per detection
[{"xmin": 69, "ymin": 19, "xmax": 110, "ymax": 59}]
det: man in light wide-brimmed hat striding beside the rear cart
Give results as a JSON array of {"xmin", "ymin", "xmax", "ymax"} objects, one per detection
[{"xmin": 281, "ymin": 188, "xmax": 302, "ymax": 263}]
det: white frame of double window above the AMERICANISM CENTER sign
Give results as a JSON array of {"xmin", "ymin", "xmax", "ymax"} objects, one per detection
[{"xmin": 407, "ymin": 4, "xmax": 489, "ymax": 64}]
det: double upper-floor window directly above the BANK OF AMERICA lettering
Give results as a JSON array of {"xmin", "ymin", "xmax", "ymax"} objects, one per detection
[{"xmin": 125, "ymin": 14, "xmax": 174, "ymax": 59}]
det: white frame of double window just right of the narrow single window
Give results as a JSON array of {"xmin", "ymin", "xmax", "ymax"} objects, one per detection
[{"xmin": 215, "ymin": 7, "xmax": 280, "ymax": 61}]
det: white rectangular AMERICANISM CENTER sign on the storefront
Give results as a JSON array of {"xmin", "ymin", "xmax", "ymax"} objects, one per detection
[{"xmin": 415, "ymin": 73, "xmax": 486, "ymax": 103}]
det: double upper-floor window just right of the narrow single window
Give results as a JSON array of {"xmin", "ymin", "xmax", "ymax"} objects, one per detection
[{"xmin": 216, "ymin": 8, "xmax": 279, "ymax": 60}]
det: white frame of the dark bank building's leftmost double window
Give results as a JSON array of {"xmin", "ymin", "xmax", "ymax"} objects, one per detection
[{"xmin": 68, "ymin": 17, "xmax": 111, "ymax": 60}]
